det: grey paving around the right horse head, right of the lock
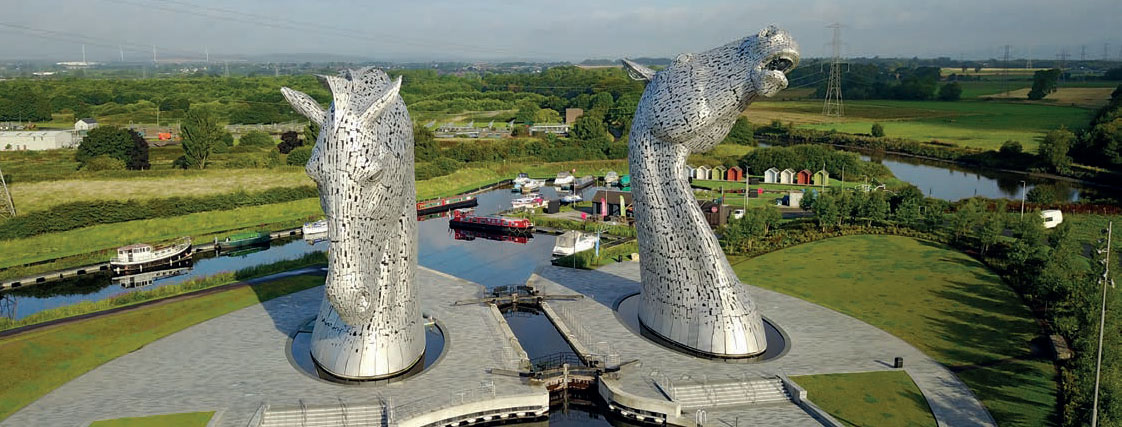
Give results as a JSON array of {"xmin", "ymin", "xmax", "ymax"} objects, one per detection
[{"xmin": 531, "ymin": 262, "xmax": 996, "ymax": 426}]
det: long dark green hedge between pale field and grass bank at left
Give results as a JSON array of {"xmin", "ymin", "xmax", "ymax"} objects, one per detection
[{"xmin": 0, "ymin": 186, "xmax": 319, "ymax": 240}]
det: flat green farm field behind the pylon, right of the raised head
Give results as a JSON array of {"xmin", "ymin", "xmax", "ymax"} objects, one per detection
[{"xmin": 746, "ymin": 101, "xmax": 1094, "ymax": 152}]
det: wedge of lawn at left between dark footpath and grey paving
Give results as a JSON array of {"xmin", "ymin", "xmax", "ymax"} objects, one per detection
[{"xmin": 0, "ymin": 276, "xmax": 323, "ymax": 419}]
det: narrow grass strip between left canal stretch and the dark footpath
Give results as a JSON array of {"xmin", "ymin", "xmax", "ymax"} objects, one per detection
[{"xmin": 0, "ymin": 252, "xmax": 328, "ymax": 331}]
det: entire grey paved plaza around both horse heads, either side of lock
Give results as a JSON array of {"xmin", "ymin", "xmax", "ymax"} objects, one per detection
[{"xmin": 2, "ymin": 262, "xmax": 994, "ymax": 426}]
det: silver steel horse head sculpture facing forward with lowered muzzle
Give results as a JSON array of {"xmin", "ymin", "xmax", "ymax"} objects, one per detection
[{"xmin": 282, "ymin": 67, "xmax": 424, "ymax": 377}]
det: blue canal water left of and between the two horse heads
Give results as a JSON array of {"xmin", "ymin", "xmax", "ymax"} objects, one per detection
[{"xmin": 0, "ymin": 182, "xmax": 610, "ymax": 319}]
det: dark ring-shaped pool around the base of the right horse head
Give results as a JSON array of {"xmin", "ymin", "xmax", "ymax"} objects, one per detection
[{"xmin": 614, "ymin": 294, "xmax": 791, "ymax": 363}]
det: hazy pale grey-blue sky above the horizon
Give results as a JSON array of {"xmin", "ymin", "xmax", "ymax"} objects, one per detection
[{"xmin": 0, "ymin": 0, "xmax": 1122, "ymax": 62}]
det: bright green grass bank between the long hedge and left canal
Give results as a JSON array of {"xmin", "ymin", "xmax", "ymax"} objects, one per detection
[{"xmin": 0, "ymin": 198, "xmax": 322, "ymax": 268}]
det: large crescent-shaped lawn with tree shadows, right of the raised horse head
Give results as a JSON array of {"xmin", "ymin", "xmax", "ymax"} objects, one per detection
[{"xmin": 732, "ymin": 235, "xmax": 1056, "ymax": 426}]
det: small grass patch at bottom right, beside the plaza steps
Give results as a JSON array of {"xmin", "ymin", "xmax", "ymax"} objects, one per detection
[{"xmin": 791, "ymin": 371, "xmax": 936, "ymax": 426}]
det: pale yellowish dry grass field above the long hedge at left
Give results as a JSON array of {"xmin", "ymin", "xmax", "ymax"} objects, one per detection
[{"xmin": 9, "ymin": 167, "xmax": 313, "ymax": 214}]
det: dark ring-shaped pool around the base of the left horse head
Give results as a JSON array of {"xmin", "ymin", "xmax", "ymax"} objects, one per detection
[{"xmin": 285, "ymin": 317, "xmax": 445, "ymax": 386}]
